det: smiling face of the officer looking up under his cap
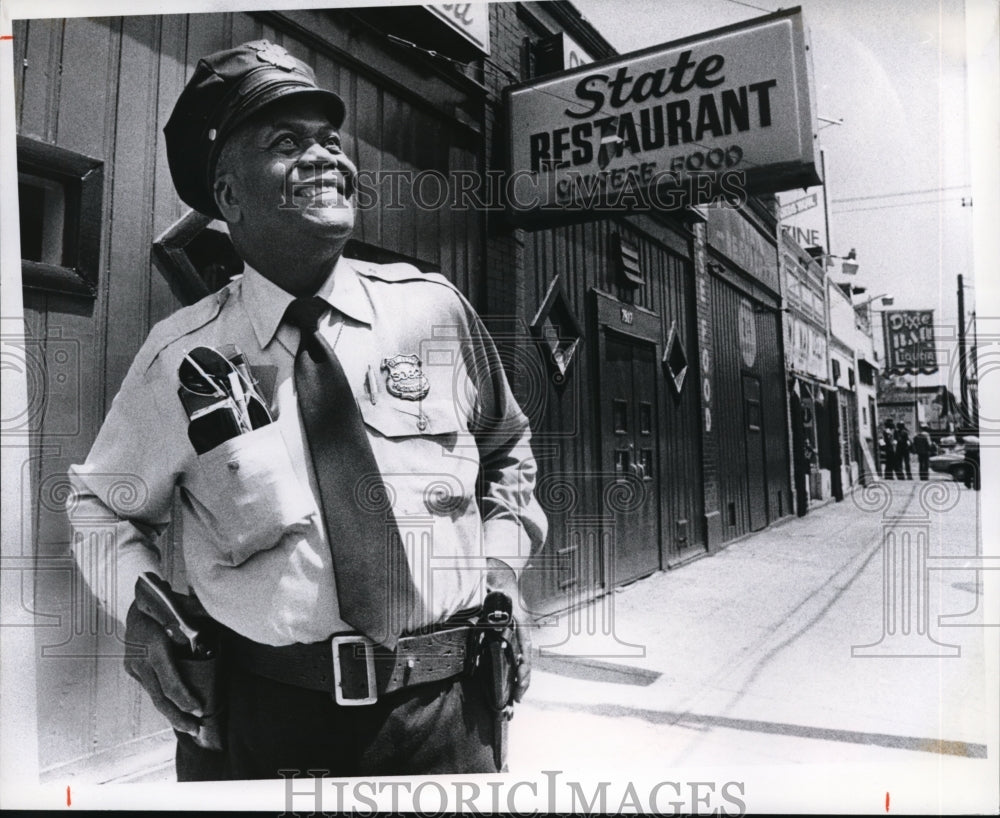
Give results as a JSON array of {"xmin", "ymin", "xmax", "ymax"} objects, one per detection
[{"xmin": 215, "ymin": 96, "xmax": 357, "ymax": 290}]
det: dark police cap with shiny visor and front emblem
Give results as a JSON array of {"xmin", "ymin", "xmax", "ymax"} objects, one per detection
[{"xmin": 163, "ymin": 40, "xmax": 344, "ymax": 218}]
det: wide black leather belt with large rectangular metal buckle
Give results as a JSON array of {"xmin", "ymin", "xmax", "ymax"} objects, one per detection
[{"xmin": 223, "ymin": 625, "xmax": 473, "ymax": 706}]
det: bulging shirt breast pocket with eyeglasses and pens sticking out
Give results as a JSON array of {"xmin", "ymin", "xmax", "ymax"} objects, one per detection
[{"xmin": 188, "ymin": 423, "xmax": 316, "ymax": 566}]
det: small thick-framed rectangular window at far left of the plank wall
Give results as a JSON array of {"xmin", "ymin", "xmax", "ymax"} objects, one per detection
[{"xmin": 17, "ymin": 136, "xmax": 104, "ymax": 297}]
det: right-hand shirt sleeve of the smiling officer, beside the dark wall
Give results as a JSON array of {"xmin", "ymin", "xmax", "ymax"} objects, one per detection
[{"xmin": 459, "ymin": 295, "xmax": 548, "ymax": 571}]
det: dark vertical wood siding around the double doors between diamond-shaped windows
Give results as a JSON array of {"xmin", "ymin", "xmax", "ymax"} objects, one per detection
[{"xmin": 525, "ymin": 218, "xmax": 705, "ymax": 609}]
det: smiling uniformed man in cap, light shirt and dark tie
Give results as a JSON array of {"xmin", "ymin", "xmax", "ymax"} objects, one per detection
[{"xmin": 69, "ymin": 40, "xmax": 546, "ymax": 780}]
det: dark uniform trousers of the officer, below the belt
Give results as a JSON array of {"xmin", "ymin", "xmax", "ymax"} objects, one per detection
[{"xmin": 176, "ymin": 672, "xmax": 498, "ymax": 781}]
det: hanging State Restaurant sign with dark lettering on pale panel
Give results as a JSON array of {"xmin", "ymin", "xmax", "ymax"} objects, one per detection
[{"xmin": 505, "ymin": 8, "xmax": 821, "ymax": 227}]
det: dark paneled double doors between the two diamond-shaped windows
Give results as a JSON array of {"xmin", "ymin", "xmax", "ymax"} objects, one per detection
[{"xmin": 600, "ymin": 330, "xmax": 660, "ymax": 585}]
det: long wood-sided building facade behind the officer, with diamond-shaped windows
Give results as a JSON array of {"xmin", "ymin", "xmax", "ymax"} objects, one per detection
[{"xmin": 14, "ymin": 2, "xmax": 796, "ymax": 778}]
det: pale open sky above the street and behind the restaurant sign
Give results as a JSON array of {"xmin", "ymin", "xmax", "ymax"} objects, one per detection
[{"xmin": 573, "ymin": 0, "xmax": 990, "ymax": 388}]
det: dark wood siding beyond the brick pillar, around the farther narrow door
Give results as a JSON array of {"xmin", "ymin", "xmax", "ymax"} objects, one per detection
[{"xmin": 712, "ymin": 276, "xmax": 792, "ymax": 541}]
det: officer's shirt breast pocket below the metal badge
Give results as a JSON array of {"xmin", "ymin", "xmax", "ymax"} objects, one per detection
[{"xmin": 361, "ymin": 400, "xmax": 479, "ymax": 521}]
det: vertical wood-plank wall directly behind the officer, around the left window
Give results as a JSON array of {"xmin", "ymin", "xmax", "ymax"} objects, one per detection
[{"xmin": 14, "ymin": 11, "xmax": 482, "ymax": 770}]
